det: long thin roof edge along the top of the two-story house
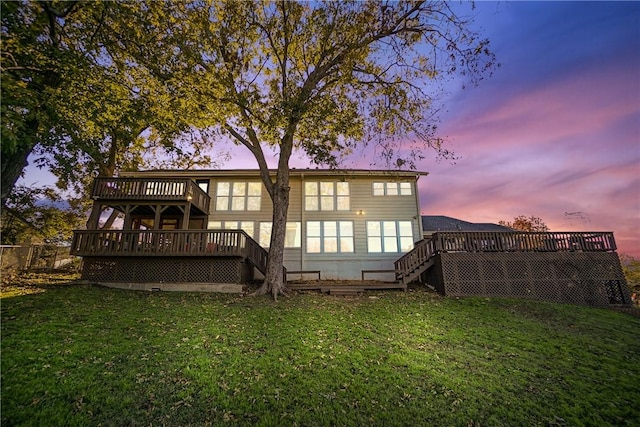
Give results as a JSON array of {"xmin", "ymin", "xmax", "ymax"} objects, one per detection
[{"xmin": 120, "ymin": 168, "xmax": 428, "ymax": 178}]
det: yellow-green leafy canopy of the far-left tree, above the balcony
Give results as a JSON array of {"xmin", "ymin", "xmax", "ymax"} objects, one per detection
[{"xmin": 1, "ymin": 1, "xmax": 220, "ymax": 207}]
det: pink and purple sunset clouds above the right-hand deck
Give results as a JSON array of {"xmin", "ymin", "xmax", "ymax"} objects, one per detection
[{"xmin": 412, "ymin": 66, "xmax": 640, "ymax": 256}]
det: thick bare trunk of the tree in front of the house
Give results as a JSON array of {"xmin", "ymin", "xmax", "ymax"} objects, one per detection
[{"xmin": 256, "ymin": 179, "xmax": 289, "ymax": 300}]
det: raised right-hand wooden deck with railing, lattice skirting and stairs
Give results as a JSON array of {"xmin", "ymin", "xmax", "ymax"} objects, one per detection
[{"xmin": 395, "ymin": 231, "xmax": 631, "ymax": 307}]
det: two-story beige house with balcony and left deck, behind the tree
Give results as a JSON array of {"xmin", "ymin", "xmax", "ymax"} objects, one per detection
[{"xmin": 74, "ymin": 169, "xmax": 426, "ymax": 292}]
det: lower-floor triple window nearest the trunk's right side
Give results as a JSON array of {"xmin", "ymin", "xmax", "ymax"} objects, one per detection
[{"xmin": 307, "ymin": 221, "xmax": 354, "ymax": 253}]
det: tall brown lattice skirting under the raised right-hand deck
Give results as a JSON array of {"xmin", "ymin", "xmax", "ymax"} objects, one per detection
[{"xmin": 426, "ymin": 252, "xmax": 631, "ymax": 307}]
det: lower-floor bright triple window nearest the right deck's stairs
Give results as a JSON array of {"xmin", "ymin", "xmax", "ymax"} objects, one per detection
[{"xmin": 367, "ymin": 221, "xmax": 413, "ymax": 253}]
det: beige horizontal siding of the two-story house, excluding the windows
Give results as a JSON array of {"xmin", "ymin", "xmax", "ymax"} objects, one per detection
[{"xmin": 122, "ymin": 170, "xmax": 424, "ymax": 280}]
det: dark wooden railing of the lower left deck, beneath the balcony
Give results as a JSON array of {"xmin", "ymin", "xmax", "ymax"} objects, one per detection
[{"xmin": 71, "ymin": 230, "xmax": 267, "ymax": 273}]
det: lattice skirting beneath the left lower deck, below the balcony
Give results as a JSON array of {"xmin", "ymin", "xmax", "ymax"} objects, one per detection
[{"xmin": 82, "ymin": 257, "xmax": 253, "ymax": 283}]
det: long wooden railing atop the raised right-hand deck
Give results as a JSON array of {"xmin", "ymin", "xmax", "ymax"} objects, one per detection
[{"xmin": 433, "ymin": 231, "xmax": 616, "ymax": 252}]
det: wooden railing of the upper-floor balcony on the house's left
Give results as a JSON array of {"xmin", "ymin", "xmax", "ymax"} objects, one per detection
[{"xmin": 91, "ymin": 178, "xmax": 211, "ymax": 212}]
